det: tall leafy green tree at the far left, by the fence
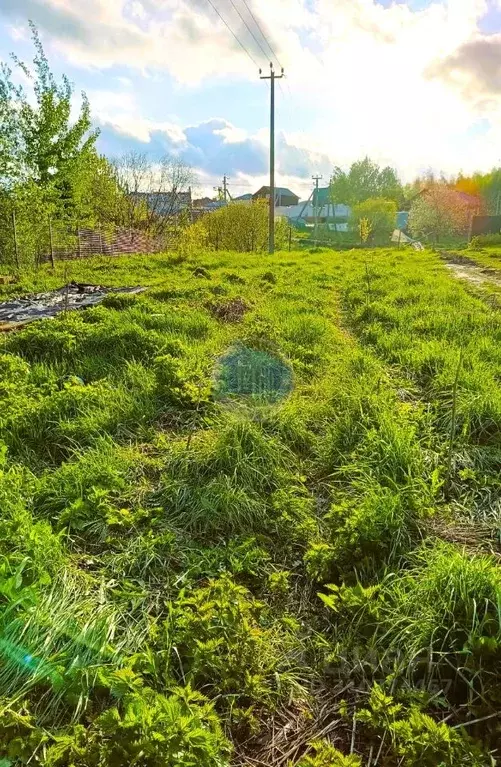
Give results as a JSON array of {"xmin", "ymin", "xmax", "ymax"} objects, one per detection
[{"xmin": 0, "ymin": 23, "xmax": 137, "ymax": 271}]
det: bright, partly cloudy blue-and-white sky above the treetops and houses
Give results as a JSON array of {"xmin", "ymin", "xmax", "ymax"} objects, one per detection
[{"xmin": 0, "ymin": 0, "xmax": 501, "ymax": 198}]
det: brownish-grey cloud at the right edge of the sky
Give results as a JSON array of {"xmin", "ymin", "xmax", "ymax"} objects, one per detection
[{"xmin": 426, "ymin": 35, "xmax": 501, "ymax": 97}]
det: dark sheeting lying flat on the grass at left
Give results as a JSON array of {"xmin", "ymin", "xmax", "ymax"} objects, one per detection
[{"xmin": 0, "ymin": 282, "xmax": 146, "ymax": 325}]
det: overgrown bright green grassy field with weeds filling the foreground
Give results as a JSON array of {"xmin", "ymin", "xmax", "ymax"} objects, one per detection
[{"xmin": 0, "ymin": 249, "xmax": 501, "ymax": 767}]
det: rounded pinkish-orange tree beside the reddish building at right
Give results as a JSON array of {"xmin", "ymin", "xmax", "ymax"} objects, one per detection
[{"xmin": 409, "ymin": 185, "xmax": 472, "ymax": 243}]
